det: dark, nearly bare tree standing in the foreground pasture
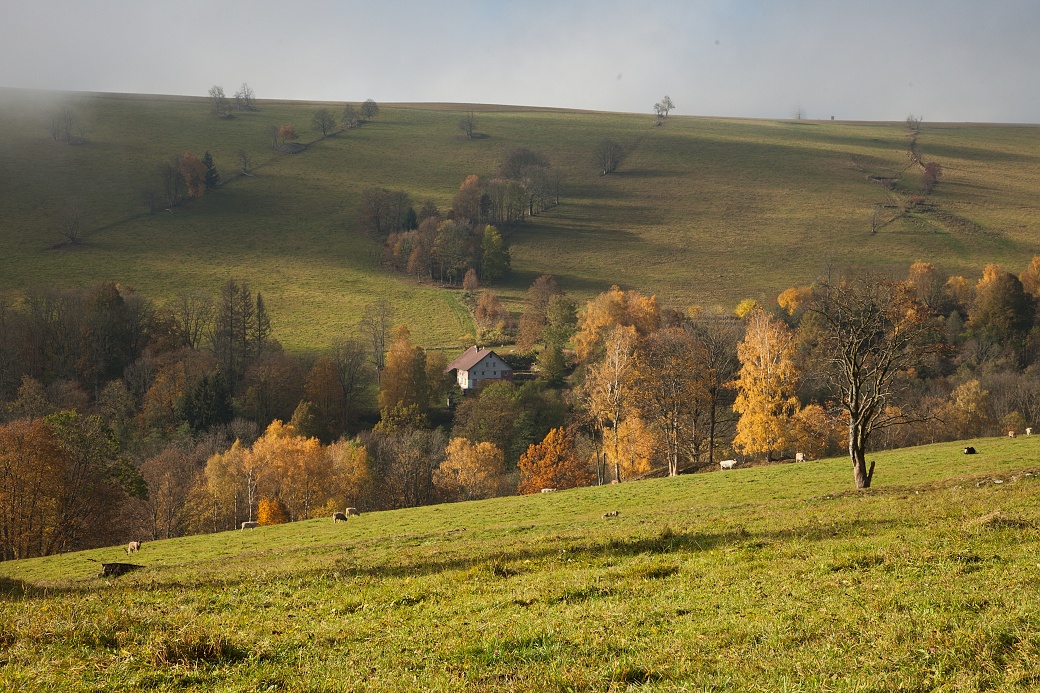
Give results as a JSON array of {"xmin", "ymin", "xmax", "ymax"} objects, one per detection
[{"xmin": 809, "ymin": 276, "xmax": 940, "ymax": 488}]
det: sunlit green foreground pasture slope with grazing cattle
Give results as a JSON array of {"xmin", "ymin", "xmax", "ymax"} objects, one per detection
[{"xmin": 6, "ymin": 437, "xmax": 1040, "ymax": 692}]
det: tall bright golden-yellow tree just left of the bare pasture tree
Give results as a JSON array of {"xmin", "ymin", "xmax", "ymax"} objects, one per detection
[{"xmin": 733, "ymin": 310, "xmax": 798, "ymax": 460}]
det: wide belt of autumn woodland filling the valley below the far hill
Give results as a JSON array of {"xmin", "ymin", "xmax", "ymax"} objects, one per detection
[{"xmin": 0, "ymin": 257, "xmax": 1040, "ymax": 559}]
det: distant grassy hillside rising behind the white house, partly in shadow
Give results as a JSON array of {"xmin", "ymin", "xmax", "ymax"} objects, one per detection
[{"xmin": 0, "ymin": 89, "xmax": 1040, "ymax": 349}]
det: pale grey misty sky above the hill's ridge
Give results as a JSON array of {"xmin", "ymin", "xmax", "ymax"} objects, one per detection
[{"xmin": 0, "ymin": 0, "xmax": 1040, "ymax": 123}]
